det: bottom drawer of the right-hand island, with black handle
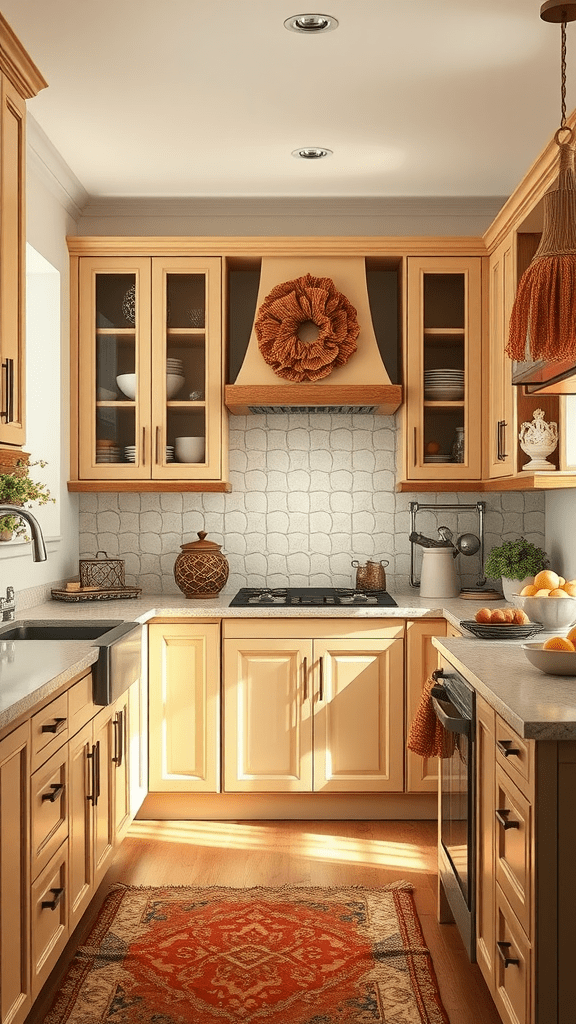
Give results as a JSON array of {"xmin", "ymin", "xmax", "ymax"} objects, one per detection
[{"xmin": 494, "ymin": 886, "xmax": 532, "ymax": 1024}]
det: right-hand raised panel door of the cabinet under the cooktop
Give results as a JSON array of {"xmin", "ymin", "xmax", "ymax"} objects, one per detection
[{"xmin": 314, "ymin": 639, "xmax": 404, "ymax": 793}]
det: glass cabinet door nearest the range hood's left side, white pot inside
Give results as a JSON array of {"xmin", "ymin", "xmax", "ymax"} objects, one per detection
[{"xmin": 152, "ymin": 257, "xmax": 221, "ymax": 479}]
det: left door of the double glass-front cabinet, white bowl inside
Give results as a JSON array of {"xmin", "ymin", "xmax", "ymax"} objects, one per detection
[{"xmin": 79, "ymin": 258, "xmax": 152, "ymax": 479}]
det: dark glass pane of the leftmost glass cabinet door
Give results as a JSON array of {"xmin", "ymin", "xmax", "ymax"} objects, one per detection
[{"xmin": 94, "ymin": 273, "xmax": 137, "ymax": 465}]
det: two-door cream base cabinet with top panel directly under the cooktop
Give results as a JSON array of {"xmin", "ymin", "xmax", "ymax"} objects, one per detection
[{"xmin": 222, "ymin": 618, "xmax": 404, "ymax": 793}]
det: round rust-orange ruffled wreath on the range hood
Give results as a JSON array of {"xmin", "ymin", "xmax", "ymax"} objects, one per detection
[{"xmin": 254, "ymin": 273, "xmax": 360, "ymax": 381}]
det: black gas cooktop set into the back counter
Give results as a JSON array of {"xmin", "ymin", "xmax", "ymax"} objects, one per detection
[{"xmin": 230, "ymin": 587, "xmax": 398, "ymax": 608}]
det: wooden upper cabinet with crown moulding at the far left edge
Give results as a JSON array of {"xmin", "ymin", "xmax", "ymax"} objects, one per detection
[{"xmin": 0, "ymin": 14, "xmax": 47, "ymax": 447}]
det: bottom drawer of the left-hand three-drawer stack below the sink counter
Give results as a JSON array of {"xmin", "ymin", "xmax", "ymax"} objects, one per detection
[{"xmin": 31, "ymin": 843, "xmax": 69, "ymax": 997}]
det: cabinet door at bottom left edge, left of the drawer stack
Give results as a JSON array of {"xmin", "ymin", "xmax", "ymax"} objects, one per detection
[{"xmin": 0, "ymin": 723, "xmax": 31, "ymax": 1024}]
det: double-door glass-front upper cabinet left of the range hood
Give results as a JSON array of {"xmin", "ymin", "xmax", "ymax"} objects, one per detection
[{"xmin": 73, "ymin": 256, "xmax": 223, "ymax": 481}]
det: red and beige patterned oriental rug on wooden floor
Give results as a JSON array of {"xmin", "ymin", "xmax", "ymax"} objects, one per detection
[{"xmin": 44, "ymin": 882, "xmax": 449, "ymax": 1024}]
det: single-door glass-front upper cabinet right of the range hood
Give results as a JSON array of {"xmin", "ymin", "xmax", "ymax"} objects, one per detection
[{"xmin": 405, "ymin": 257, "xmax": 482, "ymax": 481}]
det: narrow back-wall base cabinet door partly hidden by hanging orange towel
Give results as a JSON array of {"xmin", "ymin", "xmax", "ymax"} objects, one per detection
[{"xmin": 406, "ymin": 618, "xmax": 446, "ymax": 793}]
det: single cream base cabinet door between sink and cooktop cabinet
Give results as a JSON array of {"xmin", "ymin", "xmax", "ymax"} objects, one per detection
[{"xmin": 149, "ymin": 623, "xmax": 220, "ymax": 793}]
